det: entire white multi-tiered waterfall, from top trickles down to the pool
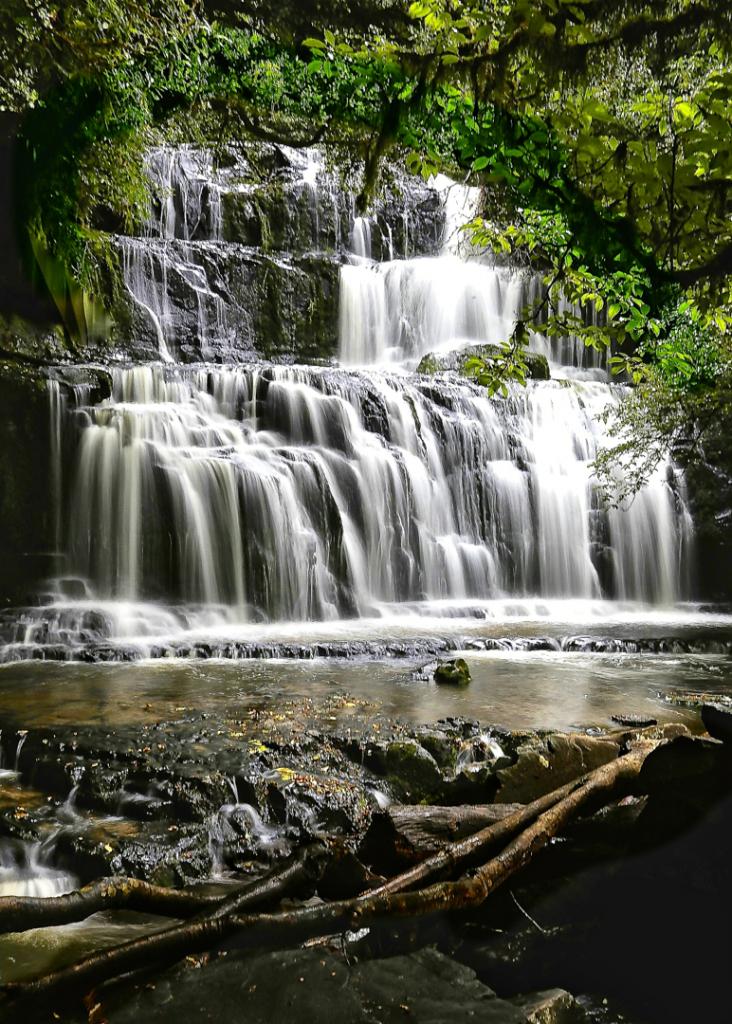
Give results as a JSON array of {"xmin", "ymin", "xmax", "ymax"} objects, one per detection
[{"xmin": 3, "ymin": 150, "xmax": 693, "ymax": 657}]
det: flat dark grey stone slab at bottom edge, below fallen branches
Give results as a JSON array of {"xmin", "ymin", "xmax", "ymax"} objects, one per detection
[{"xmin": 104, "ymin": 949, "xmax": 587, "ymax": 1024}]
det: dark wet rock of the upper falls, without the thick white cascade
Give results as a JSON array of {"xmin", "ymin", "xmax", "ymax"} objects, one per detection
[{"xmin": 106, "ymin": 143, "xmax": 444, "ymax": 362}]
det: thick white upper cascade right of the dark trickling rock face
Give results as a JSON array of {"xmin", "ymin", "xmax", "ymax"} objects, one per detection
[{"xmin": 339, "ymin": 175, "xmax": 607, "ymax": 377}]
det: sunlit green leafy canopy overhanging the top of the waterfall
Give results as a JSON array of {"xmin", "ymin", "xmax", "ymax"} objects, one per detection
[{"xmin": 0, "ymin": 0, "xmax": 732, "ymax": 417}]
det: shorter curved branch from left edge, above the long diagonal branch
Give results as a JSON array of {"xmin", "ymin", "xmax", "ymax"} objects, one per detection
[{"xmin": 0, "ymin": 846, "xmax": 325, "ymax": 934}]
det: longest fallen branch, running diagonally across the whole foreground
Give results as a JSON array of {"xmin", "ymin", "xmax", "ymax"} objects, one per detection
[{"xmin": 4, "ymin": 745, "xmax": 652, "ymax": 998}]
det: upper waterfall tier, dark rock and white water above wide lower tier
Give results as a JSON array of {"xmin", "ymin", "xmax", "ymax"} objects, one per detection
[{"xmin": 105, "ymin": 146, "xmax": 605, "ymax": 370}]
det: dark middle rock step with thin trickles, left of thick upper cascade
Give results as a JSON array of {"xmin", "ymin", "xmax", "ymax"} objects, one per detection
[{"xmin": 113, "ymin": 240, "xmax": 340, "ymax": 362}]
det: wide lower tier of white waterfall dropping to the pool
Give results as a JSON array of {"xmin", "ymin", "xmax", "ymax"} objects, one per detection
[{"xmin": 47, "ymin": 365, "xmax": 692, "ymax": 622}]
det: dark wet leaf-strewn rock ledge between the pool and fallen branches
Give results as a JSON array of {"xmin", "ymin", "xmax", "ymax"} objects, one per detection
[{"xmin": 0, "ymin": 698, "xmax": 556, "ymax": 885}]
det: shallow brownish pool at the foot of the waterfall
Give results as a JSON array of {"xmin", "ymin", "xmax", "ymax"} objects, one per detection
[{"xmin": 0, "ymin": 650, "xmax": 732, "ymax": 730}]
